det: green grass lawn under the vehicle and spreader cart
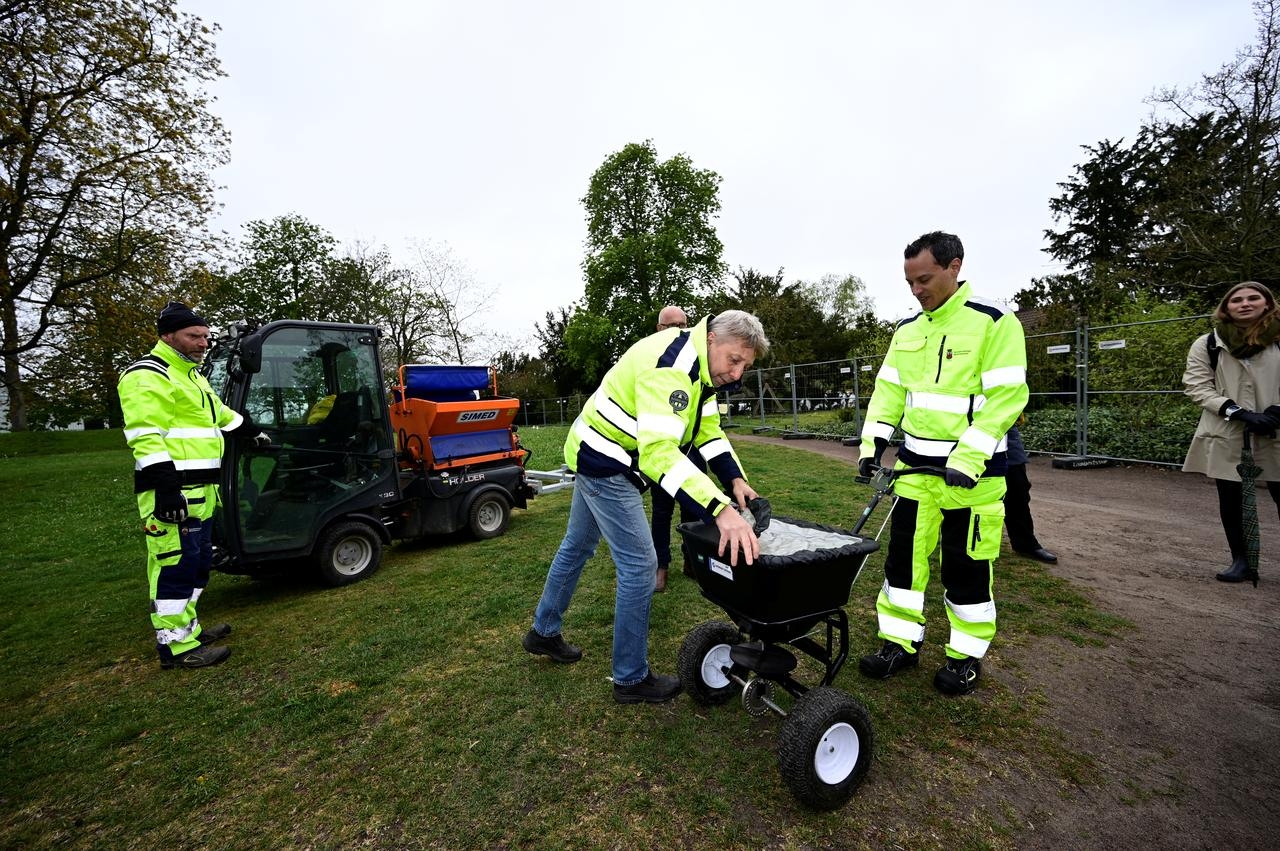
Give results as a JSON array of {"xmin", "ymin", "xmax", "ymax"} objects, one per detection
[{"xmin": 0, "ymin": 427, "xmax": 1121, "ymax": 848}]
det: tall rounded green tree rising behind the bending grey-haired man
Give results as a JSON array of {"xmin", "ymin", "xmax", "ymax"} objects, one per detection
[{"xmin": 583, "ymin": 141, "xmax": 724, "ymax": 367}]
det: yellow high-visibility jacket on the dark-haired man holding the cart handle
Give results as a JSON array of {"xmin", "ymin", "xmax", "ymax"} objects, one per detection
[{"xmin": 859, "ymin": 282, "xmax": 1028, "ymax": 479}]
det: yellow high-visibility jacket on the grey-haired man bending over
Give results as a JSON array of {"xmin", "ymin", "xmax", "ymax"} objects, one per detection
[{"xmin": 564, "ymin": 316, "xmax": 746, "ymax": 522}]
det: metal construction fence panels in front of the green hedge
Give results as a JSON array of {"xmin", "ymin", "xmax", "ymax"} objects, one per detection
[{"xmin": 516, "ymin": 315, "xmax": 1210, "ymax": 466}]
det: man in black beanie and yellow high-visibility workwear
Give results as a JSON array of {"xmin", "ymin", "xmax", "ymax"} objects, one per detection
[{"xmin": 119, "ymin": 302, "xmax": 270, "ymax": 668}]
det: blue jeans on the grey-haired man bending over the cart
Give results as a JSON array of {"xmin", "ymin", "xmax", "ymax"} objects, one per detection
[{"xmin": 534, "ymin": 476, "xmax": 658, "ymax": 686}]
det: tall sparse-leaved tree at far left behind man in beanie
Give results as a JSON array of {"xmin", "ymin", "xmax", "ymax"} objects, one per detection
[{"xmin": 0, "ymin": 0, "xmax": 228, "ymax": 431}]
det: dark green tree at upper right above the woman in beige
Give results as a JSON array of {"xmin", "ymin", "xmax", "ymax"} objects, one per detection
[{"xmin": 1039, "ymin": 0, "xmax": 1280, "ymax": 316}]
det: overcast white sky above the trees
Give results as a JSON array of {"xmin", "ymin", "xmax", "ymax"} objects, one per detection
[{"xmin": 180, "ymin": 0, "xmax": 1256, "ymax": 350}]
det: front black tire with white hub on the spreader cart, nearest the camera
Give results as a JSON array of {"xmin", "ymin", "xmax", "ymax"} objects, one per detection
[{"xmin": 778, "ymin": 687, "xmax": 874, "ymax": 810}]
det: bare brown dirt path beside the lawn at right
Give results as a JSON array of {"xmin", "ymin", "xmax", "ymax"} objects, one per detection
[{"xmin": 733, "ymin": 434, "xmax": 1280, "ymax": 848}]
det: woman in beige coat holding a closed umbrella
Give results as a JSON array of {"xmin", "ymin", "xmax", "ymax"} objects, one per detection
[{"xmin": 1183, "ymin": 280, "xmax": 1280, "ymax": 582}]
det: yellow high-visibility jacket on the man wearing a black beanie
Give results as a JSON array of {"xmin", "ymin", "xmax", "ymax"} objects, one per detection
[{"xmin": 118, "ymin": 340, "xmax": 256, "ymax": 493}]
